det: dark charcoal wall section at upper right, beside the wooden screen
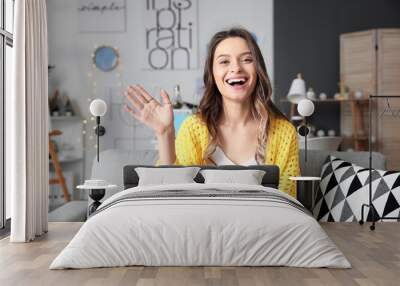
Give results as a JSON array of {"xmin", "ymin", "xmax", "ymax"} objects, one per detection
[{"xmin": 274, "ymin": 0, "xmax": 400, "ymax": 132}]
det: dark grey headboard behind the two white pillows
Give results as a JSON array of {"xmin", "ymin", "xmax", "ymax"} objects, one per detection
[{"xmin": 124, "ymin": 165, "xmax": 279, "ymax": 189}]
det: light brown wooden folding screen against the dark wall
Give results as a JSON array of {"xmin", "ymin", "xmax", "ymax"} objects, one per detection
[{"xmin": 340, "ymin": 29, "xmax": 400, "ymax": 170}]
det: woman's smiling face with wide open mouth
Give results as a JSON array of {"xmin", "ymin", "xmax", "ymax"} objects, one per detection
[{"xmin": 213, "ymin": 37, "xmax": 257, "ymax": 103}]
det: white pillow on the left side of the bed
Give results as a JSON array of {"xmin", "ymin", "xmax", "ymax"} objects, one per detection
[{"xmin": 135, "ymin": 167, "xmax": 200, "ymax": 186}]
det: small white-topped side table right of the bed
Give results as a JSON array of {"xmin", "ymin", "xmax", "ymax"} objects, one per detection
[{"xmin": 289, "ymin": 177, "xmax": 321, "ymax": 213}]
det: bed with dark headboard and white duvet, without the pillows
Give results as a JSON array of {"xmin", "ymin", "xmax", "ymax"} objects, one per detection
[{"xmin": 50, "ymin": 165, "xmax": 351, "ymax": 269}]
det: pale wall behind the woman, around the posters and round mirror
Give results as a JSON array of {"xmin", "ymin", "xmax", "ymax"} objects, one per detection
[{"xmin": 47, "ymin": 0, "xmax": 273, "ymax": 178}]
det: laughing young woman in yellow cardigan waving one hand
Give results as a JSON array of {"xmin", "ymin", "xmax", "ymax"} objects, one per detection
[{"xmin": 125, "ymin": 28, "xmax": 300, "ymax": 197}]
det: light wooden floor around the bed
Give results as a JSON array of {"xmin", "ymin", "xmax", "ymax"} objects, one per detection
[{"xmin": 0, "ymin": 223, "xmax": 400, "ymax": 286}]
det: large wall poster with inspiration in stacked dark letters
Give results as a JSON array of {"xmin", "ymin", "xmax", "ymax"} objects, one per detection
[{"xmin": 138, "ymin": 0, "xmax": 199, "ymax": 70}]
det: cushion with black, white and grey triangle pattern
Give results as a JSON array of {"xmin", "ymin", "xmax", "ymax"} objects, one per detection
[{"xmin": 313, "ymin": 156, "xmax": 400, "ymax": 222}]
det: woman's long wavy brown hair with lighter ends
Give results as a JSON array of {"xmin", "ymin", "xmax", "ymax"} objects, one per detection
[{"xmin": 198, "ymin": 27, "xmax": 287, "ymax": 164}]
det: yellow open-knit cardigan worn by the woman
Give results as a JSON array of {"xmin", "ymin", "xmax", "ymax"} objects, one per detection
[{"xmin": 163, "ymin": 115, "xmax": 300, "ymax": 197}]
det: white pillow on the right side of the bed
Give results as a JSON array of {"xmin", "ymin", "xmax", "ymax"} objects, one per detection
[{"xmin": 200, "ymin": 169, "xmax": 265, "ymax": 185}]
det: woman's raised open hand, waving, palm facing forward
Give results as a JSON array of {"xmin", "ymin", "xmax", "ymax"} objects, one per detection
[{"xmin": 124, "ymin": 85, "xmax": 174, "ymax": 136}]
